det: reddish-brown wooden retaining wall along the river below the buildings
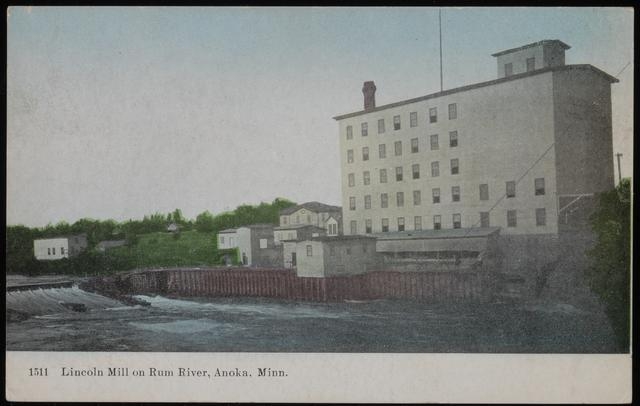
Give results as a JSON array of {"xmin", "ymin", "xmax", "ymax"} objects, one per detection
[{"xmin": 127, "ymin": 268, "xmax": 494, "ymax": 301}]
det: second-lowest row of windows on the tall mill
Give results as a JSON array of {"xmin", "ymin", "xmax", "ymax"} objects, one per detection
[{"xmin": 349, "ymin": 177, "xmax": 545, "ymax": 210}]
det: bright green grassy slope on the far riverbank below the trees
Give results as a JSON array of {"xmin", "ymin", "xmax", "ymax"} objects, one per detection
[{"xmin": 107, "ymin": 231, "xmax": 220, "ymax": 268}]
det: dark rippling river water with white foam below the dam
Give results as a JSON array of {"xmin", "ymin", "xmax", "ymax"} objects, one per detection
[{"xmin": 6, "ymin": 288, "xmax": 615, "ymax": 353}]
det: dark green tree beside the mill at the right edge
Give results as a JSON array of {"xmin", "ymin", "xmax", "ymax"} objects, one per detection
[{"xmin": 586, "ymin": 179, "xmax": 631, "ymax": 352}]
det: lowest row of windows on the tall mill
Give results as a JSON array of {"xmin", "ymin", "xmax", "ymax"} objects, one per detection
[{"xmin": 349, "ymin": 208, "xmax": 547, "ymax": 234}]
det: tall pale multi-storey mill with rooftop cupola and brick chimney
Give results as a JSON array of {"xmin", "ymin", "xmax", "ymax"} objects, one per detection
[{"xmin": 334, "ymin": 40, "xmax": 618, "ymax": 272}]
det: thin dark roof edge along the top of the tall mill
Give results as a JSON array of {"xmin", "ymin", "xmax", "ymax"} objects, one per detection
[{"xmin": 333, "ymin": 64, "xmax": 619, "ymax": 120}]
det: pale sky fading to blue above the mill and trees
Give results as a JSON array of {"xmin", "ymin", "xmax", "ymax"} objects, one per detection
[{"xmin": 7, "ymin": 7, "xmax": 634, "ymax": 227}]
